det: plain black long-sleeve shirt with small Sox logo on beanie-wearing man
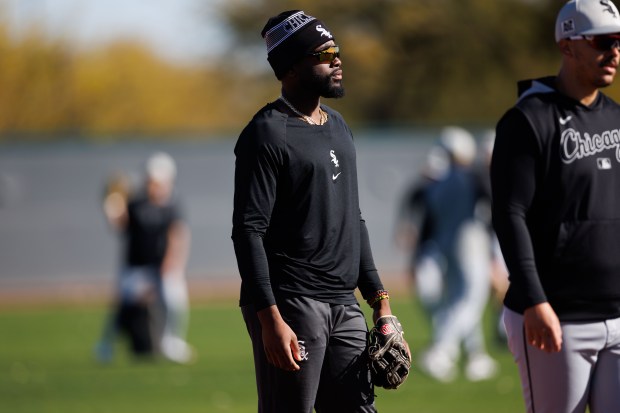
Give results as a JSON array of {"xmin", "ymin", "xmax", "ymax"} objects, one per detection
[{"xmin": 232, "ymin": 104, "xmax": 383, "ymax": 310}]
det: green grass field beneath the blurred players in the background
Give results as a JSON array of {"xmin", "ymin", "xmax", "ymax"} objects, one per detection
[{"xmin": 0, "ymin": 298, "xmax": 524, "ymax": 413}]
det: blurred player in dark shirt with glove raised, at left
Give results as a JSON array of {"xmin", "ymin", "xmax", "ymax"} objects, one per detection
[{"xmin": 96, "ymin": 153, "xmax": 194, "ymax": 363}]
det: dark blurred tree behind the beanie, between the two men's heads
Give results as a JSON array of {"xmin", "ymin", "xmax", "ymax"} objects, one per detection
[{"xmin": 222, "ymin": 0, "xmax": 612, "ymax": 124}]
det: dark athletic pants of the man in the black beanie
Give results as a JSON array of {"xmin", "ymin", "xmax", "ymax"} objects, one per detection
[{"xmin": 241, "ymin": 297, "xmax": 376, "ymax": 413}]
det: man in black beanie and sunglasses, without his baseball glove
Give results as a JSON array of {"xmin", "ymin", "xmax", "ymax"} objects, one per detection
[{"xmin": 232, "ymin": 10, "xmax": 406, "ymax": 413}]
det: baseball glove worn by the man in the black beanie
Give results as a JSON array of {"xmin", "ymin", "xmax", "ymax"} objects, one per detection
[{"xmin": 368, "ymin": 315, "xmax": 411, "ymax": 389}]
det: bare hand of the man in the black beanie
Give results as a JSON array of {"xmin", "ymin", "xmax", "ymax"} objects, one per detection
[{"xmin": 257, "ymin": 305, "xmax": 301, "ymax": 371}]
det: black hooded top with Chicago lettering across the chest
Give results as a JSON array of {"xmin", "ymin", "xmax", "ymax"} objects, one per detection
[{"xmin": 491, "ymin": 78, "xmax": 620, "ymax": 321}]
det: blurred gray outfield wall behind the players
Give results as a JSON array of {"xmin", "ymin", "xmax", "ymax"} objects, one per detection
[{"xmin": 0, "ymin": 131, "xmax": 474, "ymax": 288}]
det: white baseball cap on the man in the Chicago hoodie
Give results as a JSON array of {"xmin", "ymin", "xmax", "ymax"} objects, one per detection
[{"xmin": 555, "ymin": 0, "xmax": 620, "ymax": 42}]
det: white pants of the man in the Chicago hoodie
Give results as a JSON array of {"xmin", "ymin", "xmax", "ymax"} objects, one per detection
[{"xmin": 504, "ymin": 308, "xmax": 620, "ymax": 413}]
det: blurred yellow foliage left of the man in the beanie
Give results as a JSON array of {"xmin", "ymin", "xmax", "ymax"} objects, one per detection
[{"xmin": 0, "ymin": 27, "xmax": 260, "ymax": 138}]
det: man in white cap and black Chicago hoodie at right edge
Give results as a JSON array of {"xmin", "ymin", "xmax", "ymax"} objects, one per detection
[{"xmin": 491, "ymin": 0, "xmax": 620, "ymax": 413}]
